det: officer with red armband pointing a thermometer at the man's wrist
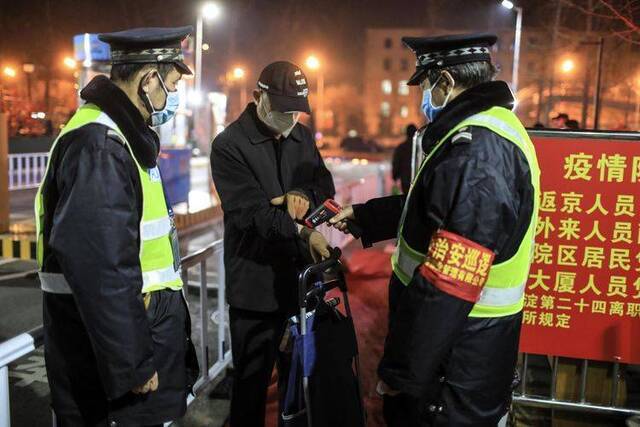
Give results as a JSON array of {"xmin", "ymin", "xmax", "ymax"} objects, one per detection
[{"xmin": 333, "ymin": 34, "xmax": 540, "ymax": 427}]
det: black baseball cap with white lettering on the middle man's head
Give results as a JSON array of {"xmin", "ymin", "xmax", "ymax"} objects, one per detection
[{"xmin": 258, "ymin": 61, "xmax": 311, "ymax": 114}]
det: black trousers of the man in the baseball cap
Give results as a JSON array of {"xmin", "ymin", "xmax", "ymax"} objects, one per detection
[{"xmin": 229, "ymin": 307, "xmax": 288, "ymax": 427}]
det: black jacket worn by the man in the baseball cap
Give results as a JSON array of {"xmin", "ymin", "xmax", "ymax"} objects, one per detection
[{"xmin": 211, "ymin": 103, "xmax": 335, "ymax": 312}]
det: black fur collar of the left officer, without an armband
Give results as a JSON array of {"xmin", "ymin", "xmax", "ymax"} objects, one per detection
[{"xmin": 80, "ymin": 76, "xmax": 160, "ymax": 168}]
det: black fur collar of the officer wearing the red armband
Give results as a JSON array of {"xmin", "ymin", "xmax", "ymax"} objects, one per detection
[{"xmin": 422, "ymin": 81, "xmax": 515, "ymax": 152}]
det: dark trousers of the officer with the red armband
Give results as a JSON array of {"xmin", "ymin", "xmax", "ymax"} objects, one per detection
[{"xmin": 383, "ymin": 312, "xmax": 522, "ymax": 427}]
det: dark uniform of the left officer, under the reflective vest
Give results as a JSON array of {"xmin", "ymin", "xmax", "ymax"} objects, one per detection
[{"xmin": 43, "ymin": 76, "xmax": 197, "ymax": 425}]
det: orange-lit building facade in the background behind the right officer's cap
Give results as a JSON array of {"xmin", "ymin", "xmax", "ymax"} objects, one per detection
[{"xmin": 363, "ymin": 27, "xmax": 640, "ymax": 138}]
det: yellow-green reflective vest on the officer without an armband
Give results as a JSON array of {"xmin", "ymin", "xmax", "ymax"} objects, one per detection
[{"xmin": 35, "ymin": 104, "xmax": 182, "ymax": 294}]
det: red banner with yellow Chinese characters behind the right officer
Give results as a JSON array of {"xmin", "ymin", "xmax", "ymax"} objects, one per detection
[{"xmin": 520, "ymin": 137, "xmax": 640, "ymax": 363}]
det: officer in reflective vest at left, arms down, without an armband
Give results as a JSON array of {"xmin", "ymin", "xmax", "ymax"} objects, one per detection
[{"xmin": 35, "ymin": 27, "xmax": 198, "ymax": 427}]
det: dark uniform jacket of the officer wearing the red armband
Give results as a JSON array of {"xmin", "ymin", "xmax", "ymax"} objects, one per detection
[{"xmin": 354, "ymin": 82, "xmax": 534, "ymax": 408}]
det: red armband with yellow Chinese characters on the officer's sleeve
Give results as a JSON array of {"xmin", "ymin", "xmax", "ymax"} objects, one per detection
[{"xmin": 420, "ymin": 230, "xmax": 495, "ymax": 303}]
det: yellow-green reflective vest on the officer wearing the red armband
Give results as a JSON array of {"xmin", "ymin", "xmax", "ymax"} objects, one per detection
[{"xmin": 392, "ymin": 107, "xmax": 540, "ymax": 317}]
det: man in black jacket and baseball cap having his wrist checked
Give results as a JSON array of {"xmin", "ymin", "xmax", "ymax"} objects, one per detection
[{"xmin": 211, "ymin": 62, "xmax": 335, "ymax": 427}]
